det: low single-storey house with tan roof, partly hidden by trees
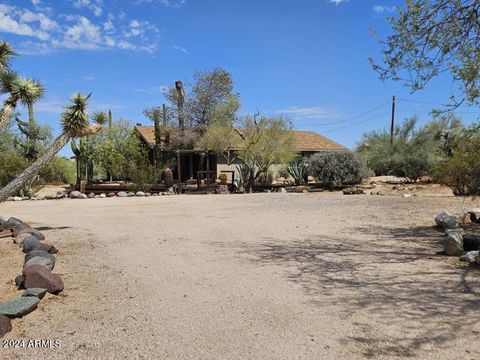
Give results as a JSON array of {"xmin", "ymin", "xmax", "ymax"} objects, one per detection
[{"xmin": 135, "ymin": 124, "xmax": 347, "ymax": 182}]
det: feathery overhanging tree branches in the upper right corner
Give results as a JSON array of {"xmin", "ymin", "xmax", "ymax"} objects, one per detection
[{"xmin": 371, "ymin": 0, "xmax": 480, "ymax": 108}]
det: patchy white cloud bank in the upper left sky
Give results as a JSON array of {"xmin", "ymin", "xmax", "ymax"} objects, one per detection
[{"xmin": 0, "ymin": 0, "xmax": 160, "ymax": 54}]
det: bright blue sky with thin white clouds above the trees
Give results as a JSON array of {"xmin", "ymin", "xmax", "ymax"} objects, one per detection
[{"xmin": 0, "ymin": 0, "xmax": 477, "ymax": 155}]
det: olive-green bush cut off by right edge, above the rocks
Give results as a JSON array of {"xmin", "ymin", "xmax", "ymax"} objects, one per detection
[{"xmin": 434, "ymin": 125, "xmax": 480, "ymax": 195}]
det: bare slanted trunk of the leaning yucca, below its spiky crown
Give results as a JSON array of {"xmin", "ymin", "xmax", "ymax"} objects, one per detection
[{"xmin": 0, "ymin": 133, "xmax": 70, "ymax": 202}]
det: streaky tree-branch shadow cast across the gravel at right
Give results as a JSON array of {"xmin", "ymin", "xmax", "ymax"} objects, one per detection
[{"xmin": 235, "ymin": 226, "xmax": 480, "ymax": 357}]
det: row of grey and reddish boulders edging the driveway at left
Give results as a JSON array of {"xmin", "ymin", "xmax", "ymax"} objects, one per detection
[{"xmin": 0, "ymin": 217, "xmax": 64, "ymax": 337}]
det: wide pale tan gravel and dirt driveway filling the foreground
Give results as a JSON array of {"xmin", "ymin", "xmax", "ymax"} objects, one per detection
[{"xmin": 0, "ymin": 193, "xmax": 480, "ymax": 359}]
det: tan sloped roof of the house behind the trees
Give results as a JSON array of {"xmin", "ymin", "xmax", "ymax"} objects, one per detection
[{"xmin": 135, "ymin": 125, "xmax": 347, "ymax": 152}]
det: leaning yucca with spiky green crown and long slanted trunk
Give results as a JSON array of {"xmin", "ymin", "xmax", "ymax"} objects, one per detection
[{"xmin": 0, "ymin": 93, "xmax": 102, "ymax": 202}]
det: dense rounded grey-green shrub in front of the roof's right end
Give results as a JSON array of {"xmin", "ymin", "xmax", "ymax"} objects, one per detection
[{"xmin": 307, "ymin": 151, "xmax": 365, "ymax": 190}]
